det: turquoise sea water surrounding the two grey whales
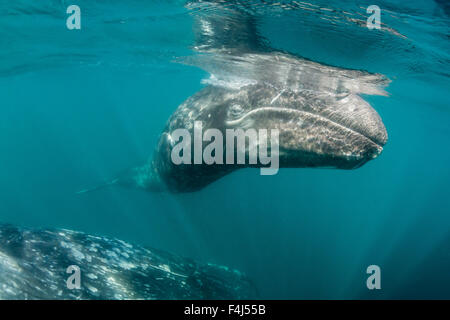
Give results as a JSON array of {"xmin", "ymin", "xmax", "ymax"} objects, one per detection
[{"xmin": 0, "ymin": 0, "xmax": 450, "ymax": 299}]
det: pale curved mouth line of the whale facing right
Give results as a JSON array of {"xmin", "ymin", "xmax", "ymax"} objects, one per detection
[{"xmin": 226, "ymin": 107, "xmax": 384, "ymax": 150}]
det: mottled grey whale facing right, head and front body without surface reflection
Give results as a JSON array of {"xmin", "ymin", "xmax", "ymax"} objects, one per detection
[{"xmin": 146, "ymin": 79, "xmax": 387, "ymax": 192}]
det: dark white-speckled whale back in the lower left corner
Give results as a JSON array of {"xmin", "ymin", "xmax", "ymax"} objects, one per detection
[{"xmin": 0, "ymin": 225, "xmax": 257, "ymax": 300}]
